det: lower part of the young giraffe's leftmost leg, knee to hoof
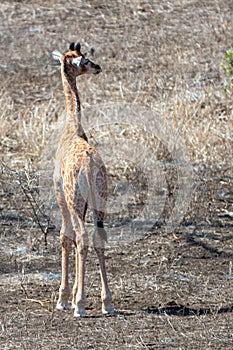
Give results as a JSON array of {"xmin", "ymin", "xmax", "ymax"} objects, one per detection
[{"xmin": 57, "ymin": 232, "xmax": 71, "ymax": 310}]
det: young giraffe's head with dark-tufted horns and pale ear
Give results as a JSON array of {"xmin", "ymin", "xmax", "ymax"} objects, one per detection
[{"xmin": 52, "ymin": 43, "xmax": 102, "ymax": 77}]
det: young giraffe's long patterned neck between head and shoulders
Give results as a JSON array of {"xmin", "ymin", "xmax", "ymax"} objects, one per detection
[{"xmin": 62, "ymin": 65, "xmax": 87, "ymax": 141}]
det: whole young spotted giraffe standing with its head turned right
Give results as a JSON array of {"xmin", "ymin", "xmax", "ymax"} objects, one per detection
[{"xmin": 53, "ymin": 43, "xmax": 114, "ymax": 317}]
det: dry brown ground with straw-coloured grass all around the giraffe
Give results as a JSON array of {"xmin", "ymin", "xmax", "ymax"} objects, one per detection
[{"xmin": 0, "ymin": 0, "xmax": 233, "ymax": 350}]
